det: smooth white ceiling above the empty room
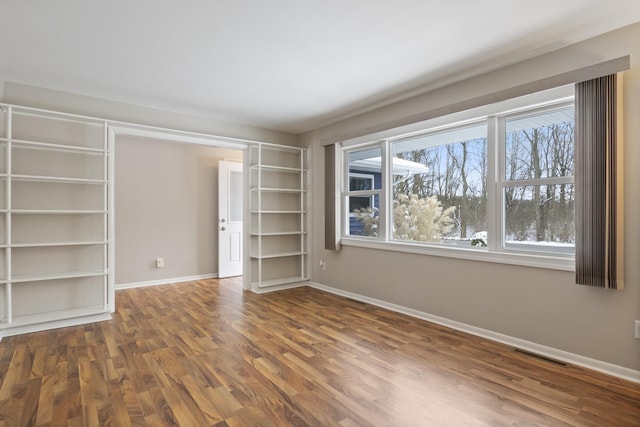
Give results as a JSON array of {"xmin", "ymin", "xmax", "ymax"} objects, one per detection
[{"xmin": 0, "ymin": 0, "xmax": 640, "ymax": 133}]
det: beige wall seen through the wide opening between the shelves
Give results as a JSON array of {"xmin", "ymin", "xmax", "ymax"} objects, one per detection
[{"xmin": 115, "ymin": 136, "xmax": 243, "ymax": 287}]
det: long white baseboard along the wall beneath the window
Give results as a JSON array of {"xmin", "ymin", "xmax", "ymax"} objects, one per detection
[{"xmin": 307, "ymin": 282, "xmax": 640, "ymax": 383}]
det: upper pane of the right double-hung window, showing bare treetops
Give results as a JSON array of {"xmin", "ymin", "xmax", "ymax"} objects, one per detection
[{"xmin": 505, "ymin": 107, "xmax": 574, "ymax": 180}]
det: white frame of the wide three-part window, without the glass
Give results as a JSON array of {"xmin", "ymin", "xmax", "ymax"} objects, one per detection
[{"xmin": 337, "ymin": 85, "xmax": 575, "ymax": 271}]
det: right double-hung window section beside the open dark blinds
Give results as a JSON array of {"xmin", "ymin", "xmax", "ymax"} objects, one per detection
[{"xmin": 500, "ymin": 105, "xmax": 575, "ymax": 253}]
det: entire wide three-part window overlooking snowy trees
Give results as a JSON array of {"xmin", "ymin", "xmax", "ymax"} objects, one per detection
[{"xmin": 342, "ymin": 88, "xmax": 575, "ymax": 265}]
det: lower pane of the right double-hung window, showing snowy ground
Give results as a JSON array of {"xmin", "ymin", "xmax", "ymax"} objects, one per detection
[{"xmin": 504, "ymin": 184, "xmax": 575, "ymax": 253}]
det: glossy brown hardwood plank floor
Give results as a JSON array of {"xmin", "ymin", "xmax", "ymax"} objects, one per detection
[{"xmin": 0, "ymin": 279, "xmax": 640, "ymax": 427}]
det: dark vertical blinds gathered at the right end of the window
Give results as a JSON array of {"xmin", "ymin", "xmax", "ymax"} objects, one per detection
[{"xmin": 575, "ymin": 74, "xmax": 624, "ymax": 289}]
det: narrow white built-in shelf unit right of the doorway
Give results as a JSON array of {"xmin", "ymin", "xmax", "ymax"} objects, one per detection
[{"xmin": 249, "ymin": 143, "xmax": 308, "ymax": 290}]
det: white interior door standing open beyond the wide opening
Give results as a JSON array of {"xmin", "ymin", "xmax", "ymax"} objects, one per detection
[{"xmin": 218, "ymin": 160, "xmax": 242, "ymax": 278}]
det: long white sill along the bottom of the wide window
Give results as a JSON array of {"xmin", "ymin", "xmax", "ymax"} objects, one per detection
[{"xmin": 340, "ymin": 237, "xmax": 575, "ymax": 271}]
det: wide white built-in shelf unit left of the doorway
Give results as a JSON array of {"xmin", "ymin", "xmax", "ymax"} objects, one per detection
[{"xmin": 0, "ymin": 104, "xmax": 114, "ymax": 339}]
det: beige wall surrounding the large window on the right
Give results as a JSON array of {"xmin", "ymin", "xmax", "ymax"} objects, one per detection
[{"xmin": 301, "ymin": 24, "xmax": 640, "ymax": 371}]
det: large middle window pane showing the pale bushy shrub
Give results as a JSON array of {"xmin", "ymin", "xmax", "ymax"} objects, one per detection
[{"xmin": 392, "ymin": 123, "xmax": 487, "ymax": 248}]
